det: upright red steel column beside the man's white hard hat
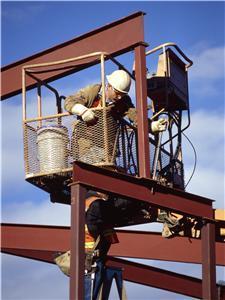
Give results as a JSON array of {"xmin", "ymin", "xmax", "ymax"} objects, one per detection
[{"xmin": 135, "ymin": 44, "xmax": 151, "ymax": 178}]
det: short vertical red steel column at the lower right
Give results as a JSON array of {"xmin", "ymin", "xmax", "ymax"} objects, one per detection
[{"xmin": 201, "ymin": 223, "xmax": 217, "ymax": 300}]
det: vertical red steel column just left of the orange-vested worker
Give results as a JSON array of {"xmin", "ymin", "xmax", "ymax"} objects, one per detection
[{"xmin": 70, "ymin": 183, "xmax": 86, "ymax": 300}]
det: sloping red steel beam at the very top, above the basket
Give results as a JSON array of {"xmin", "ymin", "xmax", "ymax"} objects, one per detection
[{"xmin": 1, "ymin": 12, "xmax": 144, "ymax": 100}]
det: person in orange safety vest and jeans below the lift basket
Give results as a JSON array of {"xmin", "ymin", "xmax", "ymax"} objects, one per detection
[{"xmin": 54, "ymin": 190, "xmax": 155, "ymax": 300}]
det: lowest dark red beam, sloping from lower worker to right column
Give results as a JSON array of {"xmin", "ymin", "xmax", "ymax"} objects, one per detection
[{"xmin": 107, "ymin": 257, "xmax": 202, "ymax": 299}]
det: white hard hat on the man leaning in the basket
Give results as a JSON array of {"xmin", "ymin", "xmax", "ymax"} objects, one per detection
[{"xmin": 106, "ymin": 70, "xmax": 131, "ymax": 94}]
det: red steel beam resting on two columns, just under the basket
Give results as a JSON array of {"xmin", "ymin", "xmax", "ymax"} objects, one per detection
[{"xmin": 73, "ymin": 162, "xmax": 213, "ymax": 218}]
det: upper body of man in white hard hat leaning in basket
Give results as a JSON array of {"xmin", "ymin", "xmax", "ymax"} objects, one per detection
[{"xmin": 64, "ymin": 70, "xmax": 166, "ymax": 134}]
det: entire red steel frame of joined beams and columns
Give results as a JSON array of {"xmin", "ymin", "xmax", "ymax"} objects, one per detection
[{"xmin": 1, "ymin": 12, "xmax": 225, "ymax": 300}]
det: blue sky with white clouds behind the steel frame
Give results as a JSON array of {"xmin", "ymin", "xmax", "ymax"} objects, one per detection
[{"xmin": 1, "ymin": 1, "xmax": 225, "ymax": 300}]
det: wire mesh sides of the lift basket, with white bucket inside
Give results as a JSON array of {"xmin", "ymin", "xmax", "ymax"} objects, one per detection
[{"xmin": 24, "ymin": 108, "xmax": 183, "ymax": 193}]
